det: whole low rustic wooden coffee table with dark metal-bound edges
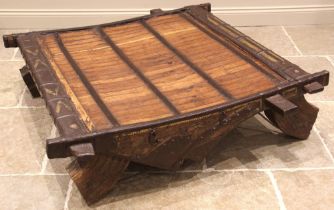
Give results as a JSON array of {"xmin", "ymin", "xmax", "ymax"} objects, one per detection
[{"xmin": 4, "ymin": 4, "xmax": 329, "ymax": 204}]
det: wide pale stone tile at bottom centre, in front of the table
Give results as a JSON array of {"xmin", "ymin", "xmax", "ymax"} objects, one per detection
[{"xmin": 69, "ymin": 172, "xmax": 278, "ymax": 210}]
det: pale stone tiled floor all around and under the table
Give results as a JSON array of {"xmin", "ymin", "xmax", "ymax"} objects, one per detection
[{"xmin": 0, "ymin": 25, "xmax": 334, "ymax": 210}]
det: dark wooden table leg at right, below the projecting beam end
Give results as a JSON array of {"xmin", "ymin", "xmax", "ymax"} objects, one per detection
[{"xmin": 265, "ymin": 96, "xmax": 319, "ymax": 139}]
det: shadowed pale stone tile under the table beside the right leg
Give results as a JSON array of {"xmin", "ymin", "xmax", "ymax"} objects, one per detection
[{"xmin": 207, "ymin": 118, "xmax": 333, "ymax": 169}]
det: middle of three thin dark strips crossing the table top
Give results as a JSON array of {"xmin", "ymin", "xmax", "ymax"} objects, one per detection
[{"xmin": 95, "ymin": 27, "xmax": 180, "ymax": 114}]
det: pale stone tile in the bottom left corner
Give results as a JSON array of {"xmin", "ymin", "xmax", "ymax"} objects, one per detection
[{"xmin": 0, "ymin": 176, "xmax": 69, "ymax": 210}]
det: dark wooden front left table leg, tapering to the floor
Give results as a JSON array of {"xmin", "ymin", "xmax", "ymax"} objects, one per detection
[{"xmin": 67, "ymin": 156, "xmax": 129, "ymax": 205}]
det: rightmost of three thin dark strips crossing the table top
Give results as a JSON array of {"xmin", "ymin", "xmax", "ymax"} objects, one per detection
[{"xmin": 141, "ymin": 21, "xmax": 233, "ymax": 99}]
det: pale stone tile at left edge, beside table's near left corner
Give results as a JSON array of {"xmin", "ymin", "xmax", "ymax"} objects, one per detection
[{"xmin": 0, "ymin": 108, "xmax": 52, "ymax": 174}]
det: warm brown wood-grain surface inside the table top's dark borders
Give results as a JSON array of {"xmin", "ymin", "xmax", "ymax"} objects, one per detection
[{"xmin": 39, "ymin": 14, "xmax": 279, "ymax": 130}]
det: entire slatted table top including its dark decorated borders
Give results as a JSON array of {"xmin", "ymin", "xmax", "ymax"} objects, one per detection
[{"xmin": 9, "ymin": 5, "xmax": 328, "ymax": 139}]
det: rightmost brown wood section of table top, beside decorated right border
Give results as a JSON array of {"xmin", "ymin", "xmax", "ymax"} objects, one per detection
[{"xmin": 146, "ymin": 14, "xmax": 276, "ymax": 99}]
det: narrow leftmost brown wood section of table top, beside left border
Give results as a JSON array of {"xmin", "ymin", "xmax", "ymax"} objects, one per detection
[{"xmin": 39, "ymin": 34, "xmax": 112, "ymax": 130}]
